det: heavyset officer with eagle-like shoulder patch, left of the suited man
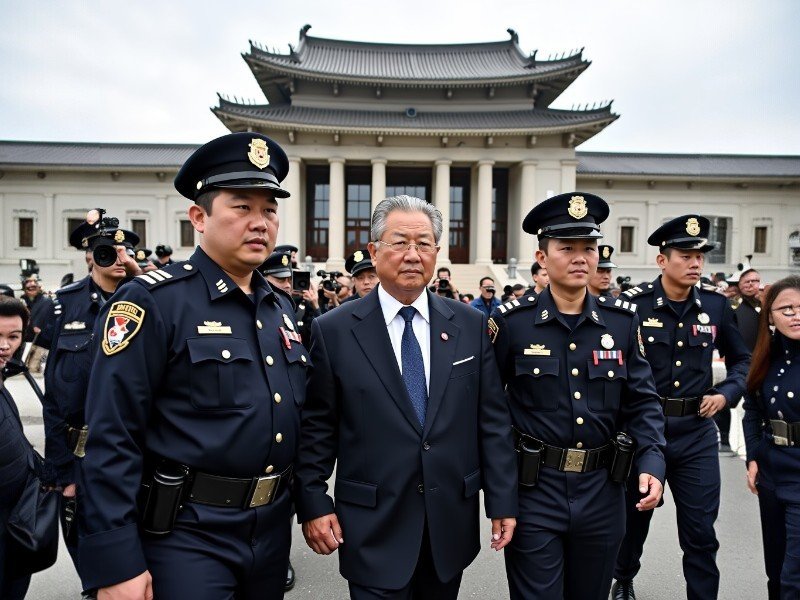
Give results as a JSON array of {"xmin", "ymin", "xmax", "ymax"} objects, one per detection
[{"xmin": 79, "ymin": 133, "xmax": 310, "ymax": 600}]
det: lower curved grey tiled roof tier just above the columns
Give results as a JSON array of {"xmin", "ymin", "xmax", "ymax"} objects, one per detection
[{"xmin": 212, "ymin": 98, "xmax": 617, "ymax": 136}]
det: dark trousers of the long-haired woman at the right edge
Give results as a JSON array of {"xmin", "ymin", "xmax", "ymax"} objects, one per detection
[{"xmin": 758, "ymin": 486, "xmax": 800, "ymax": 600}]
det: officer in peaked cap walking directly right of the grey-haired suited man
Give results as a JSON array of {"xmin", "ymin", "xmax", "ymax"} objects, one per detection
[{"xmin": 489, "ymin": 193, "xmax": 664, "ymax": 600}]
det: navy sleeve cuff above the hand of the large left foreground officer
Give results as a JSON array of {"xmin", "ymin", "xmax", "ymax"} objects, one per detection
[{"xmin": 78, "ymin": 523, "xmax": 147, "ymax": 590}]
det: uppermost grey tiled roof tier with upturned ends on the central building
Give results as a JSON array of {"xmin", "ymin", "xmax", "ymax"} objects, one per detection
[{"xmin": 243, "ymin": 26, "xmax": 590, "ymax": 87}]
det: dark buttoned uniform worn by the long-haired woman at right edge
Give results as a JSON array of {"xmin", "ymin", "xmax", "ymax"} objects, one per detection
[{"xmin": 742, "ymin": 332, "xmax": 800, "ymax": 599}]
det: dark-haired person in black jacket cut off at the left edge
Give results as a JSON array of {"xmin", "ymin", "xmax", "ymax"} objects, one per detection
[{"xmin": 0, "ymin": 296, "xmax": 31, "ymax": 600}]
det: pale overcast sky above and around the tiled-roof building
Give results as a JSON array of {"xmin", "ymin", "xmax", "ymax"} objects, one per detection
[{"xmin": 0, "ymin": 0, "xmax": 800, "ymax": 154}]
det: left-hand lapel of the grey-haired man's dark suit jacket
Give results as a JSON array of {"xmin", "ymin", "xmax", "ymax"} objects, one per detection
[{"xmin": 352, "ymin": 287, "xmax": 422, "ymax": 435}]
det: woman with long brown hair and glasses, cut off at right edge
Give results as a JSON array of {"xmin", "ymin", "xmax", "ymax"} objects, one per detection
[{"xmin": 743, "ymin": 276, "xmax": 800, "ymax": 599}]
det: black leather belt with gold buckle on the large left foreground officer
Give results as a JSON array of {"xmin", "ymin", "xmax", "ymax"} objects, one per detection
[{"xmin": 186, "ymin": 466, "xmax": 292, "ymax": 508}]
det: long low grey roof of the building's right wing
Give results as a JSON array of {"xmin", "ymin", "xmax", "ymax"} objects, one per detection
[{"xmin": 577, "ymin": 152, "xmax": 800, "ymax": 178}]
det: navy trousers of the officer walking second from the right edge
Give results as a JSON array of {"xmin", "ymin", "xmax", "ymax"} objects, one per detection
[{"xmin": 614, "ymin": 420, "xmax": 720, "ymax": 600}]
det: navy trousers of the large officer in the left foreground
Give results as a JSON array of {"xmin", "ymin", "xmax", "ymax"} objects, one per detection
[{"xmin": 142, "ymin": 491, "xmax": 292, "ymax": 600}]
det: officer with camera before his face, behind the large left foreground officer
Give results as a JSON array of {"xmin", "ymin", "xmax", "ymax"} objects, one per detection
[{"xmin": 43, "ymin": 210, "xmax": 139, "ymax": 568}]
